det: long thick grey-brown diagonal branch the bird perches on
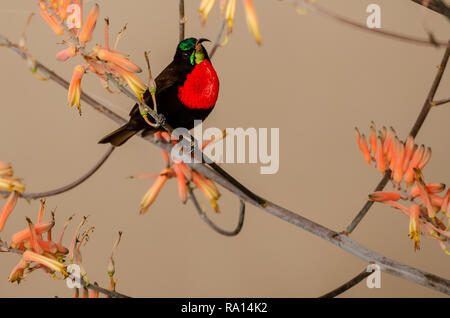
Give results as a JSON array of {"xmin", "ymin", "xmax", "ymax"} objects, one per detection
[{"xmin": 0, "ymin": 36, "xmax": 450, "ymax": 295}]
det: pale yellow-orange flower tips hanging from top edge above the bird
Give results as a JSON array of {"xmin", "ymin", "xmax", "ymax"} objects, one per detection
[{"xmin": 199, "ymin": 0, "xmax": 262, "ymax": 44}]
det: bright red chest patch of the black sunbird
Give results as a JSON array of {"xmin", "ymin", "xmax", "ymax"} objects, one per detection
[{"xmin": 178, "ymin": 60, "xmax": 219, "ymax": 109}]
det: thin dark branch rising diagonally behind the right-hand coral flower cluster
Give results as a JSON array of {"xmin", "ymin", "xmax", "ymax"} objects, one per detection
[{"xmin": 345, "ymin": 41, "xmax": 450, "ymax": 234}]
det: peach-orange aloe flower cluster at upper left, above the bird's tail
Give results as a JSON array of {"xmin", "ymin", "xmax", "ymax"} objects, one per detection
[{"xmin": 39, "ymin": 0, "xmax": 147, "ymax": 114}]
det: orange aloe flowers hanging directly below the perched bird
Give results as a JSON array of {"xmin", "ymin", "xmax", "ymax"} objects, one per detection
[{"xmin": 131, "ymin": 132, "xmax": 224, "ymax": 214}]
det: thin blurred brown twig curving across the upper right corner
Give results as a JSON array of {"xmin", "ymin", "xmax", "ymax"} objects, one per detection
[{"xmin": 297, "ymin": 0, "xmax": 448, "ymax": 47}]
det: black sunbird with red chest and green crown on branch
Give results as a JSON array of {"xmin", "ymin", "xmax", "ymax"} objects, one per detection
[{"xmin": 99, "ymin": 38, "xmax": 219, "ymax": 147}]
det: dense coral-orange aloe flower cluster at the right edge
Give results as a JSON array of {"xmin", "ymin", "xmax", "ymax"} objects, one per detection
[{"xmin": 356, "ymin": 123, "xmax": 450, "ymax": 255}]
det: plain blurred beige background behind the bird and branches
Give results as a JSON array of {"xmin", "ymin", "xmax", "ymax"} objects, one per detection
[{"xmin": 0, "ymin": 0, "xmax": 450, "ymax": 297}]
